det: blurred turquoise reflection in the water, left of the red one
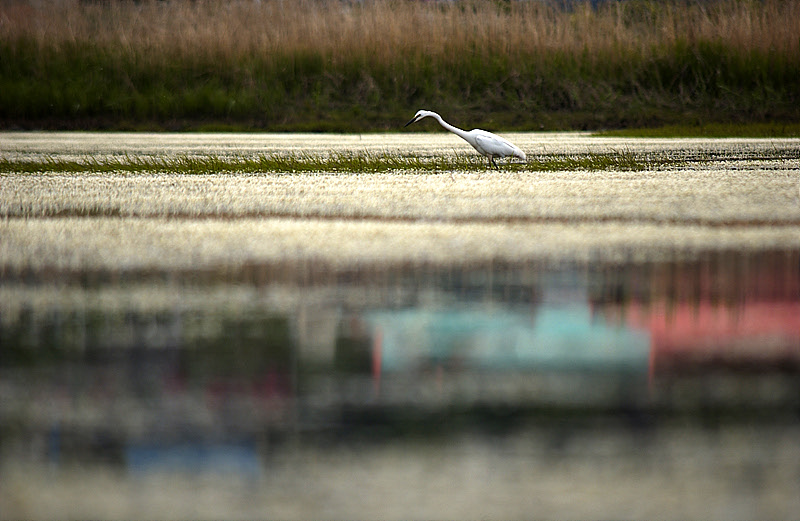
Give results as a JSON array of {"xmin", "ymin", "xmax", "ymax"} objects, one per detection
[{"xmin": 366, "ymin": 303, "xmax": 650, "ymax": 372}]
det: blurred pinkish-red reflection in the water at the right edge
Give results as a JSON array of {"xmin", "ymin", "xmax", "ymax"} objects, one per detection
[{"xmin": 597, "ymin": 252, "xmax": 800, "ymax": 376}]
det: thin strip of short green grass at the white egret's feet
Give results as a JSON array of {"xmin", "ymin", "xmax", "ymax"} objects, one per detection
[{"xmin": 0, "ymin": 152, "xmax": 683, "ymax": 174}]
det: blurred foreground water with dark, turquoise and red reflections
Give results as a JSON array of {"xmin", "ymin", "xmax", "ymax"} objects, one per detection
[{"xmin": 0, "ymin": 251, "xmax": 800, "ymax": 517}]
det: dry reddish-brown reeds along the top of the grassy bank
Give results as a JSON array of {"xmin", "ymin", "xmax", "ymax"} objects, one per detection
[{"xmin": 0, "ymin": 0, "xmax": 800, "ymax": 63}]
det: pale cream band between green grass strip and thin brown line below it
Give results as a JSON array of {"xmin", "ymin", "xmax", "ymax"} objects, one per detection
[{"xmin": 0, "ymin": 166, "xmax": 800, "ymax": 225}]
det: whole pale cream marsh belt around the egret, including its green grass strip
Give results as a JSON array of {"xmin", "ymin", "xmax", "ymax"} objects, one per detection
[{"xmin": 0, "ymin": 133, "xmax": 800, "ymax": 270}]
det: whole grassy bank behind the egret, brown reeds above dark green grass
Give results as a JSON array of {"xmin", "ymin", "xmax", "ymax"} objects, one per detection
[{"xmin": 0, "ymin": 0, "xmax": 800, "ymax": 131}]
